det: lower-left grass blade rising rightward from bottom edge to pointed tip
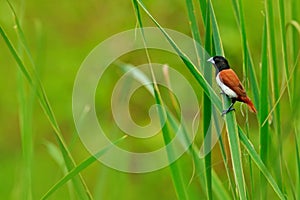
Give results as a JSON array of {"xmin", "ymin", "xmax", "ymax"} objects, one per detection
[{"xmin": 42, "ymin": 135, "xmax": 127, "ymax": 199}]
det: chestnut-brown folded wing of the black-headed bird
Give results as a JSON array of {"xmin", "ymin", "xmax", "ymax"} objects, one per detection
[{"xmin": 219, "ymin": 69, "xmax": 246, "ymax": 97}]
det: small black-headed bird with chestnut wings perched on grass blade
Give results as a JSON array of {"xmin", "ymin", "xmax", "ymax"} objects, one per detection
[{"xmin": 207, "ymin": 56, "xmax": 257, "ymax": 116}]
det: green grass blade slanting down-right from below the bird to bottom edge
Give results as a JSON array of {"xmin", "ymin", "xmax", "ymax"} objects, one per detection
[{"xmin": 238, "ymin": 128, "xmax": 285, "ymax": 199}]
